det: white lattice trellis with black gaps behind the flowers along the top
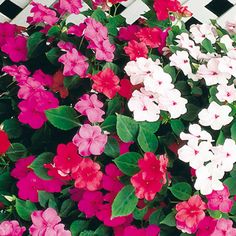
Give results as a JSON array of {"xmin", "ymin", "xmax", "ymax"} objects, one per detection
[{"xmin": 0, "ymin": 0, "xmax": 236, "ymax": 26}]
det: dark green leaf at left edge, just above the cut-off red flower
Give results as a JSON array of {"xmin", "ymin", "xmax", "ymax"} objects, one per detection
[{"xmin": 3, "ymin": 118, "xmax": 22, "ymax": 139}]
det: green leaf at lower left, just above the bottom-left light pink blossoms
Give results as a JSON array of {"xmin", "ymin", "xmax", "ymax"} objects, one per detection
[{"xmin": 15, "ymin": 198, "xmax": 37, "ymax": 221}]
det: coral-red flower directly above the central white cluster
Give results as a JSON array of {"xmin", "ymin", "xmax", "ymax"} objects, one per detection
[{"xmin": 124, "ymin": 40, "xmax": 148, "ymax": 60}]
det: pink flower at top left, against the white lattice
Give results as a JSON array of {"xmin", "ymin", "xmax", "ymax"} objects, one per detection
[{"xmin": 27, "ymin": 2, "xmax": 58, "ymax": 25}]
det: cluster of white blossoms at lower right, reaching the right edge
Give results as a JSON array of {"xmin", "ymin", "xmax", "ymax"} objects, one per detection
[{"xmin": 178, "ymin": 124, "xmax": 236, "ymax": 195}]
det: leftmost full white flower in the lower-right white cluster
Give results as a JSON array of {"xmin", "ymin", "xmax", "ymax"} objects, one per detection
[{"xmin": 178, "ymin": 141, "xmax": 214, "ymax": 169}]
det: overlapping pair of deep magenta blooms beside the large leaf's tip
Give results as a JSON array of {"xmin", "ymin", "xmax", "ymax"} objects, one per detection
[{"xmin": 18, "ymin": 91, "xmax": 59, "ymax": 129}]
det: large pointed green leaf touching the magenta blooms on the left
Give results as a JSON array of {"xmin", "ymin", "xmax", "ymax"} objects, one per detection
[{"xmin": 45, "ymin": 106, "xmax": 80, "ymax": 130}]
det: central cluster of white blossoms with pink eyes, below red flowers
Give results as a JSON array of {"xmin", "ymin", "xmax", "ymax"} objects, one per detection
[{"xmin": 125, "ymin": 57, "xmax": 187, "ymax": 122}]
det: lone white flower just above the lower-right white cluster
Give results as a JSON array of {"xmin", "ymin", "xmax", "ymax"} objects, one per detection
[{"xmin": 198, "ymin": 101, "xmax": 233, "ymax": 130}]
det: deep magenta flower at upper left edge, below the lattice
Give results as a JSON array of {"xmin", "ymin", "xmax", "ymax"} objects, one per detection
[{"xmin": 2, "ymin": 35, "xmax": 27, "ymax": 62}]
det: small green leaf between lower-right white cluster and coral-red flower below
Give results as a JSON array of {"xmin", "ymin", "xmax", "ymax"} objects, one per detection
[{"xmin": 169, "ymin": 182, "xmax": 192, "ymax": 201}]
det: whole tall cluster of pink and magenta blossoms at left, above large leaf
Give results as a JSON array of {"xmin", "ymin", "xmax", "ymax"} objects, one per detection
[{"xmin": 2, "ymin": 65, "xmax": 59, "ymax": 129}]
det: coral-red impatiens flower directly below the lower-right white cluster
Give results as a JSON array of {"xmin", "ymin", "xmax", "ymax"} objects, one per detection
[{"xmin": 175, "ymin": 195, "xmax": 207, "ymax": 234}]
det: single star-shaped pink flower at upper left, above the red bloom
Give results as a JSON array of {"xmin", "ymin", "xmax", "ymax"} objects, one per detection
[{"xmin": 58, "ymin": 48, "xmax": 89, "ymax": 77}]
